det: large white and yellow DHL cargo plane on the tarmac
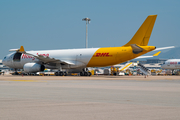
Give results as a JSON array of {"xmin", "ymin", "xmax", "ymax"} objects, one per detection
[{"xmin": 2, "ymin": 15, "xmax": 157, "ymax": 76}]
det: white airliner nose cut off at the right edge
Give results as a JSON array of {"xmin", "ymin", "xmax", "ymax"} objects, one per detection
[{"xmin": 161, "ymin": 59, "xmax": 180, "ymax": 70}]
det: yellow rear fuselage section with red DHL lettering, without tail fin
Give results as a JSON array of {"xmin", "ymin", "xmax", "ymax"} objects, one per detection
[{"xmin": 87, "ymin": 46, "xmax": 155, "ymax": 67}]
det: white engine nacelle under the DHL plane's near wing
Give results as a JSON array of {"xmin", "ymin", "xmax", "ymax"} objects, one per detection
[{"xmin": 23, "ymin": 63, "xmax": 45, "ymax": 73}]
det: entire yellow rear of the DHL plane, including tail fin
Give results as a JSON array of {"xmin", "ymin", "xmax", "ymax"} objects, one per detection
[{"xmin": 87, "ymin": 15, "xmax": 157, "ymax": 67}]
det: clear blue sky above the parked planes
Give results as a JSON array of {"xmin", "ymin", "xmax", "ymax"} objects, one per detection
[{"xmin": 0, "ymin": 0, "xmax": 180, "ymax": 59}]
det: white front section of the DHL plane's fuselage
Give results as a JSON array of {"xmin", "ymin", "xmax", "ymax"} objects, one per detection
[{"xmin": 3, "ymin": 48, "xmax": 98, "ymax": 69}]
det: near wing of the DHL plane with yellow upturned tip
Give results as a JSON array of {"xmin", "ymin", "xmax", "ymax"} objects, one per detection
[{"xmin": 15, "ymin": 46, "xmax": 74, "ymax": 65}]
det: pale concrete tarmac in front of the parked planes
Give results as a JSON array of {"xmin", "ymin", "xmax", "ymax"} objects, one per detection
[{"xmin": 0, "ymin": 75, "xmax": 180, "ymax": 120}]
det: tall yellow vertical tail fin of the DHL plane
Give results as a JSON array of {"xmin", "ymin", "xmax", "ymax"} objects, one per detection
[{"xmin": 124, "ymin": 15, "xmax": 157, "ymax": 46}]
